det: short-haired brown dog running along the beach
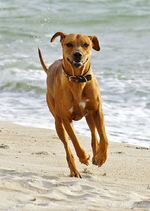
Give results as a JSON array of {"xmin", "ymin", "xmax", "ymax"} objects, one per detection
[{"xmin": 39, "ymin": 32, "xmax": 108, "ymax": 178}]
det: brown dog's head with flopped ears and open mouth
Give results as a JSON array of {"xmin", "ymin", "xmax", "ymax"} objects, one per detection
[{"xmin": 51, "ymin": 32, "xmax": 100, "ymax": 68}]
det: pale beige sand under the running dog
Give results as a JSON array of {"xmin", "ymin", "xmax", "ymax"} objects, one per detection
[{"xmin": 0, "ymin": 122, "xmax": 150, "ymax": 211}]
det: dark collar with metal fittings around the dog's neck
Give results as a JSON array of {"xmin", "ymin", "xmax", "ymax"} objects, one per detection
[{"xmin": 62, "ymin": 64, "xmax": 92, "ymax": 83}]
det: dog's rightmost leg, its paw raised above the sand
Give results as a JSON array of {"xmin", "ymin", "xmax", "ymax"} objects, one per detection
[{"xmin": 93, "ymin": 108, "xmax": 108, "ymax": 166}]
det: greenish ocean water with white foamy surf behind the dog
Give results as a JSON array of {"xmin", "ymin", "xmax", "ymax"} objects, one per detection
[{"xmin": 0, "ymin": 0, "xmax": 150, "ymax": 146}]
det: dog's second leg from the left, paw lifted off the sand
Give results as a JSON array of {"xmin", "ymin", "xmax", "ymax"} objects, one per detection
[{"xmin": 63, "ymin": 119, "xmax": 90, "ymax": 165}]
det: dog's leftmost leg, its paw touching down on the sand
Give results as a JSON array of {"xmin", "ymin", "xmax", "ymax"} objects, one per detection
[{"xmin": 55, "ymin": 117, "xmax": 81, "ymax": 178}]
